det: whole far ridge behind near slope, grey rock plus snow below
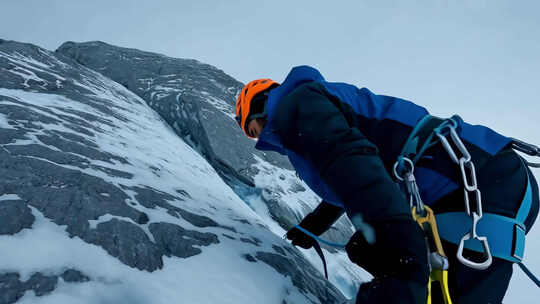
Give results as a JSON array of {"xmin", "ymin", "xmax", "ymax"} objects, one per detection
[{"xmin": 56, "ymin": 41, "xmax": 369, "ymax": 296}]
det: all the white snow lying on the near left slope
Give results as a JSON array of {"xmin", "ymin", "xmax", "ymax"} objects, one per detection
[{"xmin": 0, "ymin": 47, "xmax": 334, "ymax": 304}]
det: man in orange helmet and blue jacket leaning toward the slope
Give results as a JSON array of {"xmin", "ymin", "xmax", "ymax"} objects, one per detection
[{"xmin": 236, "ymin": 66, "xmax": 539, "ymax": 303}]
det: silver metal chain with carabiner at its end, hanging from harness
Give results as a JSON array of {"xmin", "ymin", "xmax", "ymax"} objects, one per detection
[{"xmin": 435, "ymin": 120, "xmax": 493, "ymax": 270}]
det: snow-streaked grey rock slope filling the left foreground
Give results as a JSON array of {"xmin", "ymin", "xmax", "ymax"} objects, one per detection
[{"xmin": 0, "ymin": 40, "xmax": 350, "ymax": 304}]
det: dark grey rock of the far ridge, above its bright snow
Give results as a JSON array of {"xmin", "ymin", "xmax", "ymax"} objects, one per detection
[{"xmin": 57, "ymin": 42, "xmax": 290, "ymax": 188}]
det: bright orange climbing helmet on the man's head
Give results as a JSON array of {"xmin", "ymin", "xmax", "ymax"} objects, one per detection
[{"xmin": 236, "ymin": 78, "xmax": 279, "ymax": 138}]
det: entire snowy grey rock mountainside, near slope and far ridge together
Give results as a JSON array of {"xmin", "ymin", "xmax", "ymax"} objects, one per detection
[{"xmin": 0, "ymin": 40, "xmax": 361, "ymax": 303}]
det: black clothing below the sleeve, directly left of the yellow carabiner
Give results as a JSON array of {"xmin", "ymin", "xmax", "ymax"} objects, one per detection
[{"xmin": 345, "ymin": 218, "xmax": 430, "ymax": 304}]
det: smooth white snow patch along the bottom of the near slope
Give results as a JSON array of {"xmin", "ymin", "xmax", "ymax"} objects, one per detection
[{"xmin": 0, "ymin": 208, "xmax": 307, "ymax": 304}]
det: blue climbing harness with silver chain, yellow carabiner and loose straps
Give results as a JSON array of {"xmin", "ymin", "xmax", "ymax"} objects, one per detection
[{"xmin": 284, "ymin": 115, "xmax": 540, "ymax": 304}]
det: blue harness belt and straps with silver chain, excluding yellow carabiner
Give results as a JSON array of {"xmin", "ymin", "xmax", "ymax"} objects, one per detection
[{"xmin": 394, "ymin": 115, "xmax": 540, "ymax": 287}]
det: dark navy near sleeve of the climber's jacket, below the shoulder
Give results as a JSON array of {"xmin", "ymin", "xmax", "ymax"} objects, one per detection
[{"xmin": 273, "ymin": 83, "xmax": 410, "ymax": 222}]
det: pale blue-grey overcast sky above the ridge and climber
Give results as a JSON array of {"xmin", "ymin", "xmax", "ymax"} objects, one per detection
[{"xmin": 0, "ymin": 0, "xmax": 540, "ymax": 299}]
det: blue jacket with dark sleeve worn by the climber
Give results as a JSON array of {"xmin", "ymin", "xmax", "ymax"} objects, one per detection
[{"xmin": 256, "ymin": 66, "xmax": 510, "ymax": 219}]
